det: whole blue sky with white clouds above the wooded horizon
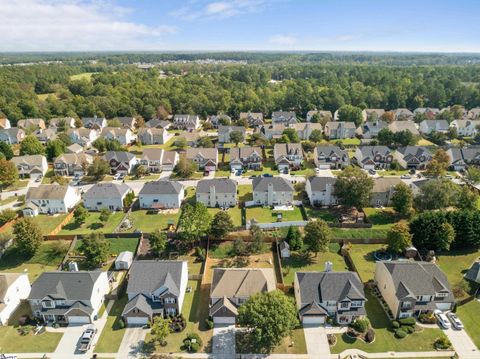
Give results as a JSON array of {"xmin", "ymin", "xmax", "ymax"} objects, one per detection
[{"xmin": 0, "ymin": 0, "xmax": 480, "ymax": 52}]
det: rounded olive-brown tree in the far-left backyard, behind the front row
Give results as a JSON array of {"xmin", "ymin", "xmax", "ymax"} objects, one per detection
[{"xmin": 13, "ymin": 217, "xmax": 43, "ymax": 258}]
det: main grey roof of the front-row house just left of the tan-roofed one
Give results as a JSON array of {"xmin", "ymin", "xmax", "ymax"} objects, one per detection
[{"xmin": 127, "ymin": 260, "xmax": 184, "ymax": 297}]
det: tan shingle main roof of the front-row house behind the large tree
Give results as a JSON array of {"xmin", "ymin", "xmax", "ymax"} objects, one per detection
[{"xmin": 210, "ymin": 268, "xmax": 276, "ymax": 298}]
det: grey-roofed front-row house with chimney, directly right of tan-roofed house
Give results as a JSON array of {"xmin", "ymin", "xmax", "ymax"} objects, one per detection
[{"xmin": 293, "ymin": 270, "xmax": 367, "ymax": 325}]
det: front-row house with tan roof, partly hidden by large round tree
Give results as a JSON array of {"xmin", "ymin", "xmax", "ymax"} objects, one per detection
[{"xmin": 209, "ymin": 268, "xmax": 276, "ymax": 324}]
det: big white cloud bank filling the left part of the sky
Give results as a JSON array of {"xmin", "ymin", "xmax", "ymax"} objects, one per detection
[{"xmin": 0, "ymin": 0, "xmax": 176, "ymax": 51}]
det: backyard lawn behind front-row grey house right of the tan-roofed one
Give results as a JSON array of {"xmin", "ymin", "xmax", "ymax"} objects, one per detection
[{"xmin": 282, "ymin": 243, "xmax": 348, "ymax": 285}]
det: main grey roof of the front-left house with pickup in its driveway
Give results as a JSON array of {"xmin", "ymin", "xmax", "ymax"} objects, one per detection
[{"xmin": 28, "ymin": 271, "xmax": 102, "ymax": 300}]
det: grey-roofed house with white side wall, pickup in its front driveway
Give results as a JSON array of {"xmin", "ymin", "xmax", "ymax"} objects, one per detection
[{"xmin": 28, "ymin": 271, "xmax": 110, "ymax": 324}]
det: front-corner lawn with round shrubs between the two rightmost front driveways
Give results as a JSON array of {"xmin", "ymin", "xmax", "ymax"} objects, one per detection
[{"xmin": 331, "ymin": 291, "xmax": 445, "ymax": 354}]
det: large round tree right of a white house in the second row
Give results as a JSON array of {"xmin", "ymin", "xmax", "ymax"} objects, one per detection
[{"xmin": 334, "ymin": 166, "xmax": 373, "ymax": 208}]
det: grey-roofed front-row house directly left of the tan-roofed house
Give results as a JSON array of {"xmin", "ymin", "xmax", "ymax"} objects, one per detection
[{"xmin": 122, "ymin": 260, "xmax": 188, "ymax": 326}]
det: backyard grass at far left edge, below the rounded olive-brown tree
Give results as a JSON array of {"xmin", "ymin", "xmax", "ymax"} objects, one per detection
[{"xmin": 0, "ymin": 241, "xmax": 70, "ymax": 282}]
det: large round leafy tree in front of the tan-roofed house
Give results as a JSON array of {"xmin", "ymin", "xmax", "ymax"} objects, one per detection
[{"xmin": 238, "ymin": 291, "xmax": 298, "ymax": 353}]
